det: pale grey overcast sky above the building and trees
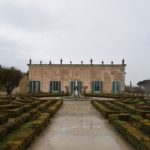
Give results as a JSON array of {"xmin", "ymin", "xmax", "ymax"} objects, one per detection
[{"xmin": 0, "ymin": 0, "xmax": 150, "ymax": 84}]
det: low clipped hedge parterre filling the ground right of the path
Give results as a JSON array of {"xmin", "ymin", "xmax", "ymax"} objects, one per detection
[{"xmin": 91, "ymin": 98, "xmax": 150, "ymax": 150}]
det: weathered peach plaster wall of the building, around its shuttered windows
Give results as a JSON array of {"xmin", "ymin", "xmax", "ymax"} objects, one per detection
[{"xmin": 28, "ymin": 63, "xmax": 126, "ymax": 93}]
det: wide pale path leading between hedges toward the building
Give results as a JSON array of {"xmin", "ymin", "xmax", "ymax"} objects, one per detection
[{"xmin": 29, "ymin": 101, "xmax": 134, "ymax": 150}]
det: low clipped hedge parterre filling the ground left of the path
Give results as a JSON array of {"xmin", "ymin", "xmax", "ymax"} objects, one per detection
[{"xmin": 0, "ymin": 97, "xmax": 63, "ymax": 150}]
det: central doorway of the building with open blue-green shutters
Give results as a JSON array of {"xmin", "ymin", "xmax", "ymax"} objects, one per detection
[{"xmin": 70, "ymin": 81, "xmax": 82, "ymax": 94}]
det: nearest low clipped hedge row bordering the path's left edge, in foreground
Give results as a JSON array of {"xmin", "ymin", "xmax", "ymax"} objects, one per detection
[{"xmin": 0, "ymin": 113, "xmax": 50, "ymax": 150}]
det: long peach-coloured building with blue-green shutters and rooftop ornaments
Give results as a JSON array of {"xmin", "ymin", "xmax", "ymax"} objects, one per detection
[{"xmin": 28, "ymin": 60, "xmax": 126, "ymax": 94}]
